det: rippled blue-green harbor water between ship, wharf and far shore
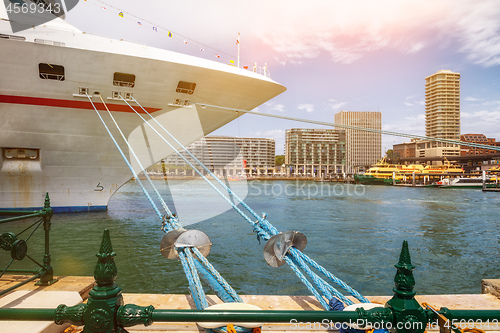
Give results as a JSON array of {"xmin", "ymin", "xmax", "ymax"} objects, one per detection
[{"xmin": 0, "ymin": 180, "xmax": 500, "ymax": 295}]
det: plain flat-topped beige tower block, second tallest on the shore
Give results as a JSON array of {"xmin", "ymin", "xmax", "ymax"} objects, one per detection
[{"xmin": 335, "ymin": 111, "xmax": 382, "ymax": 173}]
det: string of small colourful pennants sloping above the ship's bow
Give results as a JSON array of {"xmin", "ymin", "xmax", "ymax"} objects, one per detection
[{"xmin": 84, "ymin": 0, "xmax": 257, "ymax": 71}]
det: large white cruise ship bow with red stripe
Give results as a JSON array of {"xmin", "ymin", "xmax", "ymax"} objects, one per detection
[{"xmin": 0, "ymin": 1, "xmax": 286, "ymax": 212}]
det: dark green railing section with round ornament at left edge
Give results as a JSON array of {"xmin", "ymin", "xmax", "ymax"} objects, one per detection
[{"xmin": 0, "ymin": 193, "xmax": 57, "ymax": 296}]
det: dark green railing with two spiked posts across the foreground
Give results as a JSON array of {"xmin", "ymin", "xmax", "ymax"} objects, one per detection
[{"xmin": 0, "ymin": 230, "xmax": 500, "ymax": 333}]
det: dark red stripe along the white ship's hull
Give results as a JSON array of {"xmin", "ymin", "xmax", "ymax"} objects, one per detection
[{"xmin": 0, "ymin": 95, "xmax": 161, "ymax": 113}]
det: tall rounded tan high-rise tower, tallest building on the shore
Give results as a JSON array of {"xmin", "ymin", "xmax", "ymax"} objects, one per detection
[{"xmin": 417, "ymin": 70, "xmax": 460, "ymax": 157}]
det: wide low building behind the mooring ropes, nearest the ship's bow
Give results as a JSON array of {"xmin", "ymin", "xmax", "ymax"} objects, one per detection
[{"xmin": 165, "ymin": 136, "xmax": 276, "ymax": 176}]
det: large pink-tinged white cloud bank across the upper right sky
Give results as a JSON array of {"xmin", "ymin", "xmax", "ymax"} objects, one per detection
[{"xmin": 250, "ymin": 0, "xmax": 500, "ymax": 66}]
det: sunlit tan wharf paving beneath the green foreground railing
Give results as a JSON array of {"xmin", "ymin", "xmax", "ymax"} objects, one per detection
[{"xmin": 0, "ymin": 275, "xmax": 500, "ymax": 333}]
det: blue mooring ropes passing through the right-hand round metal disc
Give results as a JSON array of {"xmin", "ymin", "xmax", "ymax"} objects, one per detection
[{"xmin": 121, "ymin": 97, "xmax": 369, "ymax": 310}]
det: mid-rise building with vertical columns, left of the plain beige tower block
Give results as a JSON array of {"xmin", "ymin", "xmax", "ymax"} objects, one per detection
[{"xmin": 285, "ymin": 128, "xmax": 346, "ymax": 177}]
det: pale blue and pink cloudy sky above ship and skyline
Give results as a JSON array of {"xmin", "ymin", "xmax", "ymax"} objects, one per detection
[{"xmin": 62, "ymin": 0, "xmax": 500, "ymax": 154}]
